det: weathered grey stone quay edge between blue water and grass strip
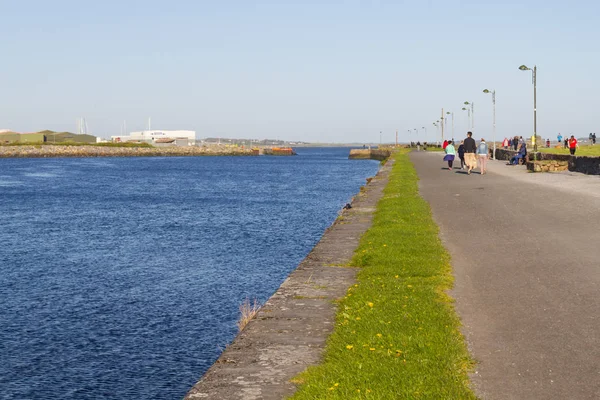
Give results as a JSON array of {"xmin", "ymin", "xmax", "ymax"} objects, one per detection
[{"xmin": 185, "ymin": 161, "xmax": 393, "ymax": 400}]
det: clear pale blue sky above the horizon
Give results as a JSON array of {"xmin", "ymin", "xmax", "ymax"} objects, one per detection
[{"xmin": 0, "ymin": 0, "xmax": 600, "ymax": 143}]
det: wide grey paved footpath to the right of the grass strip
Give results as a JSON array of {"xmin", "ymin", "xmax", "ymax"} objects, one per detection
[{"xmin": 411, "ymin": 152, "xmax": 600, "ymax": 400}]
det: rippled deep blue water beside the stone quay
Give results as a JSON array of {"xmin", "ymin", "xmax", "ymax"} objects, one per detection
[{"xmin": 0, "ymin": 148, "xmax": 378, "ymax": 399}]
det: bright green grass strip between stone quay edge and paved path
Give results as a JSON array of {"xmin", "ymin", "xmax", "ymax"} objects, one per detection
[{"xmin": 292, "ymin": 150, "xmax": 476, "ymax": 400}]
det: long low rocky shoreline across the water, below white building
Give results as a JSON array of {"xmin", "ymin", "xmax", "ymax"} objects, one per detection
[{"xmin": 0, "ymin": 145, "xmax": 257, "ymax": 158}]
